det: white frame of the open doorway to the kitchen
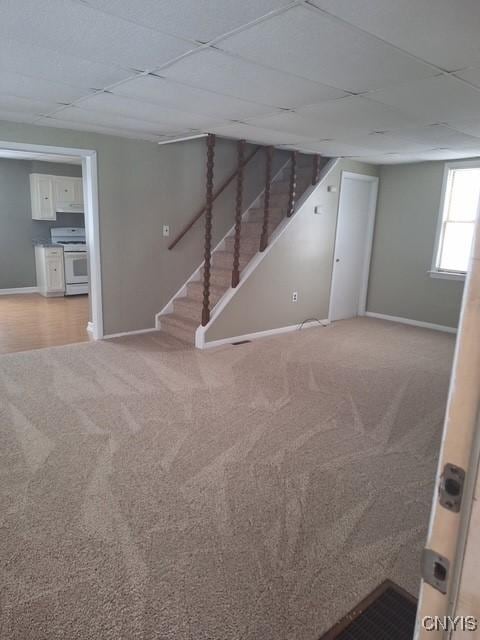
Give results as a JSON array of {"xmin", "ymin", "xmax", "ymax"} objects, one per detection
[{"xmin": 0, "ymin": 140, "xmax": 104, "ymax": 340}]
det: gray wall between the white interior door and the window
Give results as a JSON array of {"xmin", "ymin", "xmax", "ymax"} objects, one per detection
[{"xmin": 367, "ymin": 162, "xmax": 463, "ymax": 327}]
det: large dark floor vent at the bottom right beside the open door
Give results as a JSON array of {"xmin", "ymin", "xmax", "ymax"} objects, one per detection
[{"xmin": 320, "ymin": 580, "xmax": 417, "ymax": 640}]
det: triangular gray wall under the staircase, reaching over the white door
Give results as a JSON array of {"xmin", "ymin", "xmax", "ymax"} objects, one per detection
[{"xmin": 206, "ymin": 160, "xmax": 378, "ymax": 341}]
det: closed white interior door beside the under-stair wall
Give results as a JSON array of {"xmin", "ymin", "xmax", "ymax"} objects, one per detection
[{"xmin": 329, "ymin": 171, "xmax": 378, "ymax": 320}]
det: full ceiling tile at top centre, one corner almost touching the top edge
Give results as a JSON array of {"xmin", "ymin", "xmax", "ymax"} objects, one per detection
[{"xmin": 218, "ymin": 6, "xmax": 434, "ymax": 92}]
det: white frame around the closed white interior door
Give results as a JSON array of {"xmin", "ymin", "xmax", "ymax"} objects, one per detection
[{"xmin": 328, "ymin": 171, "xmax": 379, "ymax": 322}]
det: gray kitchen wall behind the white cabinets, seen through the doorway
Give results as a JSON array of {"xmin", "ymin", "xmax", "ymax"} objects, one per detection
[{"xmin": 0, "ymin": 158, "xmax": 84, "ymax": 289}]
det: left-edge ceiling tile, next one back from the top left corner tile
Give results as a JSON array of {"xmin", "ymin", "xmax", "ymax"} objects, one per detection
[{"xmin": 0, "ymin": 38, "xmax": 137, "ymax": 89}]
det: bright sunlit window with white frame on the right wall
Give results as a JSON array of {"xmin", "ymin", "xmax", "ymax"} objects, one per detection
[{"xmin": 433, "ymin": 165, "xmax": 480, "ymax": 275}]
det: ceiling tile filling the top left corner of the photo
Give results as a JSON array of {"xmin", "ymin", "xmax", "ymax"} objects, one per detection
[{"xmin": 0, "ymin": 0, "xmax": 194, "ymax": 70}]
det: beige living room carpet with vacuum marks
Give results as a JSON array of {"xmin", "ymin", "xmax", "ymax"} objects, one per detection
[{"xmin": 0, "ymin": 319, "xmax": 454, "ymax": 640}]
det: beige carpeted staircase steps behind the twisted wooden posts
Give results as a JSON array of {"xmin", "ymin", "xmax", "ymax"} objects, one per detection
[{"xmin": 160, "ymin": 149, "xmax": 326, "ymax": 344}]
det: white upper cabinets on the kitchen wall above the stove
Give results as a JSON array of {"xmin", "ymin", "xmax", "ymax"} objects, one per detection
[{"xmin": 30, "ymin": 173, "xmax": 83, "ymax": 220}]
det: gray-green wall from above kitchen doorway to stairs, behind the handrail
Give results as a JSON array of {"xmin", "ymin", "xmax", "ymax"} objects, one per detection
[{"xmin": 0, "ymin": 122, "xmax": 285, "ymax": 334}]
